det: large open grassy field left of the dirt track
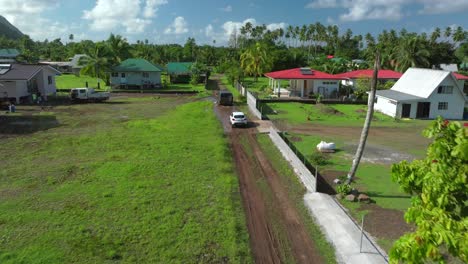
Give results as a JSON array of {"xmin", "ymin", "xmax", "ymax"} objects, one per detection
[{"xmin": 0, "ymin": 96, "xmax": 252, "ymax": 263}]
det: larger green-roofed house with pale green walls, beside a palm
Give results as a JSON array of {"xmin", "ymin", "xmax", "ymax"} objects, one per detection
[{"xmin": 110, "ymin": 59, "xmax": 162, "ymax": 89}]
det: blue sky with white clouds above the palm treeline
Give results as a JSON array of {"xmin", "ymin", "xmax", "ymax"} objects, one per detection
[{"xmin": 0, "ymin": 0, "xmax": 468, "ymax": 45}]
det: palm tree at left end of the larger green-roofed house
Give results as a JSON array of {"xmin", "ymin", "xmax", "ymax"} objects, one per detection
[{"xmin": 78, "ymin": 42, "xmax": 113, "ymax": 84}]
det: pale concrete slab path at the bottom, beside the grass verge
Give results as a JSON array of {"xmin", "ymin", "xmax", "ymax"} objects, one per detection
[{"xmin": 304, "ymin": 193, "xmax": 388, "ymax": 264}]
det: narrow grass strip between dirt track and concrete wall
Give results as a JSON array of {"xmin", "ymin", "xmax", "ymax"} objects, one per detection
[{"xmin": 257, "ymin": 134, "xmax": 336, "ymax": 263}]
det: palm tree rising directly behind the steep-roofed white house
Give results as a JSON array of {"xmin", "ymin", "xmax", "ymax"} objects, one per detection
[{"xmin": 392, "ymin": 36, "xmax": 431, "ymax": 72}]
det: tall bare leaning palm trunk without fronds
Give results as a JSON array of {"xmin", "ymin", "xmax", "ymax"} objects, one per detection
[{"xmin": 346, "ymin": 53, "xmax": 380, "ymax": 184}]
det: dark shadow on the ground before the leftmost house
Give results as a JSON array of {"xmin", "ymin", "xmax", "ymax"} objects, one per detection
[{"xmin": 0, "ymin": 115, "xmax": 60, "ymax": 135}]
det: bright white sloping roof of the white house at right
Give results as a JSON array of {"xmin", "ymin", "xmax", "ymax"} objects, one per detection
[{"xmin": 392, "ymin": 68, "xmax": 450, "ymax": 98}]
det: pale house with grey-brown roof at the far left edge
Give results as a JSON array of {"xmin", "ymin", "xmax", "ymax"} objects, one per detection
[{"xmin": 0, "ymin": 64, "xmax": 60, "ymax": 104}]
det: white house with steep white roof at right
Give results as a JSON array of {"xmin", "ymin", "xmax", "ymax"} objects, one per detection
[{"xmin": 375, "ymin": 68, "xmax": 466, "ymax": 119}]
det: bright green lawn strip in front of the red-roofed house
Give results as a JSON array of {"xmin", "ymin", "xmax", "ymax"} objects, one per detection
[{"xmin": 267, "ymin": 103, "xmax": 427, "ymax": 127}]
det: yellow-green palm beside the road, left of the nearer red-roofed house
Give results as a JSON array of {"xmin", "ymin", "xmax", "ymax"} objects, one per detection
[{"xmin": 240, "ymin": 42, "xmax": 271, "ymax": 82}]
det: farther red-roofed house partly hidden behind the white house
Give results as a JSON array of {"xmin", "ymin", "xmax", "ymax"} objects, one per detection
[{"xmin": 335, "ymin": 70, "xmax": 403, "ymax": 87}]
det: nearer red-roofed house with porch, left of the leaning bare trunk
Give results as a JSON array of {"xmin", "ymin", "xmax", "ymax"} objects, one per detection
[{"xmin": 265, "ymin": 68, "xmax": 341, "ymax": 98}]
